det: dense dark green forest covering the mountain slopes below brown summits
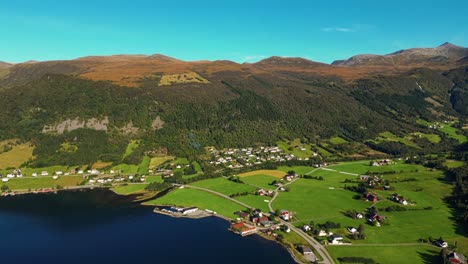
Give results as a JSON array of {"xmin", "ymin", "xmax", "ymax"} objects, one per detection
[{"xmin": 0, "ymin": 66, "xmax": 467, "ymax": 166}]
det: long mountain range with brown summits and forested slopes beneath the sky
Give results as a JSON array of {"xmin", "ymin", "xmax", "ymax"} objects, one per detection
[{"xmin": 0, "ymin": 43, "xmax": 468, "ymax": 166}]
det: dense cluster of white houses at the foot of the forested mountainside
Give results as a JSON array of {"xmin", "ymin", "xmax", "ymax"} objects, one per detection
[{"xmin": 208, "ymin": 147, "xmax": 317, "ymax": 169}]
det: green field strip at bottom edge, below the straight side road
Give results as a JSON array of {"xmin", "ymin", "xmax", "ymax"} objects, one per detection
[{"xmin": 328, "ymin": 246, "xmax": 441, "ymax": 264}]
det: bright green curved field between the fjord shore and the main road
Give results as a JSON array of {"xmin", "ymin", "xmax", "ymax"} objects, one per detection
[{"xmin": 145, "ymin": 188, "xmax": 246, "ymax": 219}]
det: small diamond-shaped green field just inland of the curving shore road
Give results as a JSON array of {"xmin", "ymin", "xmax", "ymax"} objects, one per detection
[{"xmin": 191, "ymin": 177, "xmax": 256, "ymax": 195}]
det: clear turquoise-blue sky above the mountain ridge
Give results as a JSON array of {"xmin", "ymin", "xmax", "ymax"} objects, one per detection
[{"xmin": 0, "ymin": 0, "xmax": 468, "ymax": 63}]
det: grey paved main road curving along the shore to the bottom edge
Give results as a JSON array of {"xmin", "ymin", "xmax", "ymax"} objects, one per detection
[{"xmin": 181, "ymin": 182, "xmax": 334, "ymax": 264}]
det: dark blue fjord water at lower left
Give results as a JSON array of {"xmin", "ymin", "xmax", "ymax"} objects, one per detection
[{"xmin": 0, "ymin": 190, "xmax": 294, "ymax": 263}]
